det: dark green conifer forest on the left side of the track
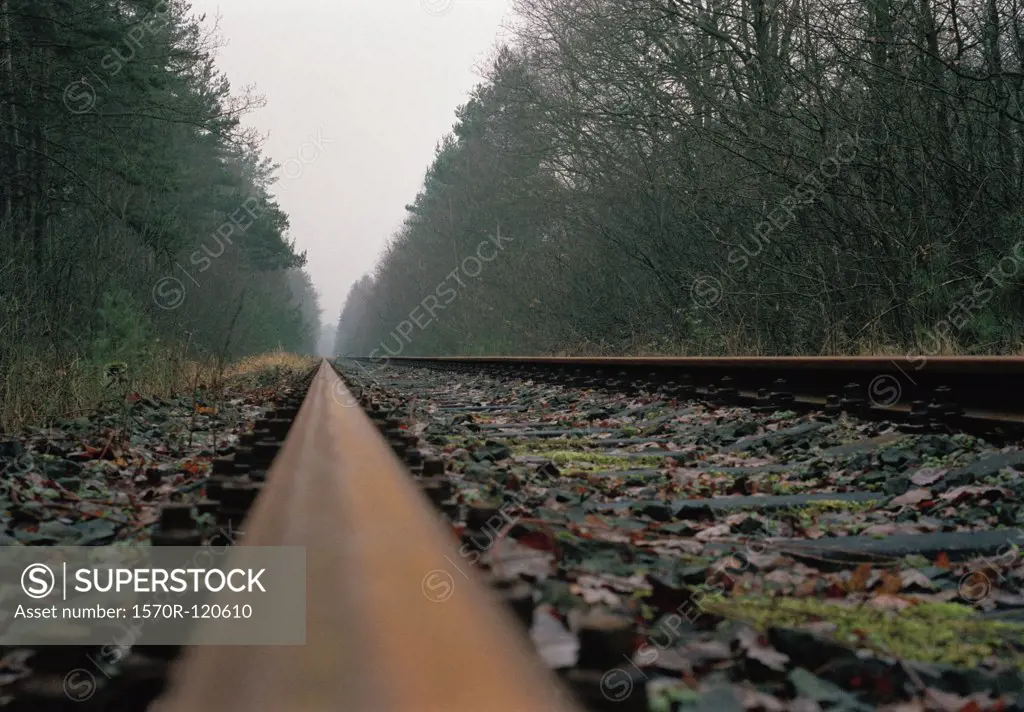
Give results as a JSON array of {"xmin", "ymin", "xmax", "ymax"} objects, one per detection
[{"xmin": 0, "ymin": 0, "xmax": 319, "ymax": 425}]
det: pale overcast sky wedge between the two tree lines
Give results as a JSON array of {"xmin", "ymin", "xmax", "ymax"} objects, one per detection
[{"xmin": 193, "ymin": 0, "xmax": 509, "ymax": 350}]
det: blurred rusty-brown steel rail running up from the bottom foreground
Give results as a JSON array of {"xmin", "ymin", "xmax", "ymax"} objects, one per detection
[{"xmin": 151, "ymin": 361, "xmax": 579, "ymax": 712}]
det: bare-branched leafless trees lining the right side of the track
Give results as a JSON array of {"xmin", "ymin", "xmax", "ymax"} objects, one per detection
[{"xmin": 335, "ymin": 0, "xmax": 1024, "ymax": 360}]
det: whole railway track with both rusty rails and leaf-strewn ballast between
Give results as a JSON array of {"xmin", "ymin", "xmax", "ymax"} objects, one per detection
[{"xmin": 10, "ymin": 359, "xmax": 1024, "ymax": 712}]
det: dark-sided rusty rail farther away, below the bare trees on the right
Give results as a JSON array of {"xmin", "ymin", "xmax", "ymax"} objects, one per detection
[{"xmin": 374, "ymin": 355, "xmax": 1024, "ymax": 428}]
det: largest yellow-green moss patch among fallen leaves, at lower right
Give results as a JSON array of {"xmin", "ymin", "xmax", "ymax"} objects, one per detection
[{"xmin": 703, "ymin": 595, "xmax": 1024, "ymax": 669}]
